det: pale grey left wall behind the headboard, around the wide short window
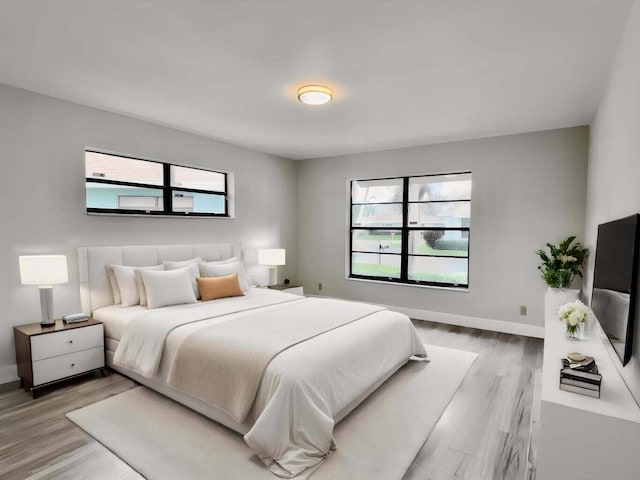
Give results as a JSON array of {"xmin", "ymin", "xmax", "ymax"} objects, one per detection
[{"xmin": 0, "ymin": 85, "xmax": 296, "ymax": 384}]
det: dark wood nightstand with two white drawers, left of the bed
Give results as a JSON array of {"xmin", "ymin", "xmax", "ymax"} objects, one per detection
[{"xmin": 13, "ymin": 319, "xmax": 104, "ymax": 398}]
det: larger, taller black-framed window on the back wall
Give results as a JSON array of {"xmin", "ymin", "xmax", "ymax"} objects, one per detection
[{"xmin": 349, "ymin": 172, "xmax": 471, "ymax": 288}]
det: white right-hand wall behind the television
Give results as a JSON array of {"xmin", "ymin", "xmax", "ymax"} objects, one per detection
[{"xmin": 585, "ymin": 2, "xmax": 640, "ymax": 402}]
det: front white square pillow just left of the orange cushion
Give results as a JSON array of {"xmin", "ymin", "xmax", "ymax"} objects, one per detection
[{"xmin": 140, "ymin": 267, "xmax": 197, "ymax": 308}]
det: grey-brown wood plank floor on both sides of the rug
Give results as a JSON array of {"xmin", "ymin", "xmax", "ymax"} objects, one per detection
[{"xmin": 0, "ymin": 321, "xmax": 543, "ymax": 480}]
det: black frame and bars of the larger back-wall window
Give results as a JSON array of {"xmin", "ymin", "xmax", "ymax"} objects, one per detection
[{"xmin": 349, "ymin": 171, "xmax": 472, "ymax": 290}]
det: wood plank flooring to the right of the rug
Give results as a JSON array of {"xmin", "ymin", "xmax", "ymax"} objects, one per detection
[{"xmin": 404, "ymin": 321, "xmax": 543, "ymax": 480}]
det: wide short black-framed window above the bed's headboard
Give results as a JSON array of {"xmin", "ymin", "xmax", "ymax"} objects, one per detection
[{"xmin": 85, "ymin": 150, "xmax": 229, "ymax": 217}]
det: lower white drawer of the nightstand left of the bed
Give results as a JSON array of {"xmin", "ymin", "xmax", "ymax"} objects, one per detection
[{"xmin": 33, "ymin": 346, "xmax": 104, "ymax": 386}]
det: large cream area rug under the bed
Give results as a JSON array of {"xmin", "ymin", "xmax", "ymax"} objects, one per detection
[{"xmin": 67, "ymin": 345, "xmax": 477, "ymax": 480}]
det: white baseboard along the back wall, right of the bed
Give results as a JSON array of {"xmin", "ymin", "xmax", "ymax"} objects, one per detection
[{"xmin": 385, "ymin": 305, "xmax": 544, "ymax": 338}]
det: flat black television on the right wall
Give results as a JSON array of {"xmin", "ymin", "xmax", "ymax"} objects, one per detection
[{"xmin": 591, "ymin": 214, "xmax": 640, "ymax": 366}]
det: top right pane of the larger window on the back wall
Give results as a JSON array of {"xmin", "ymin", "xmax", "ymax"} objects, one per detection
[{"xmin": 409, "ymin": 173, "xmax": 471, "ymax": 202}]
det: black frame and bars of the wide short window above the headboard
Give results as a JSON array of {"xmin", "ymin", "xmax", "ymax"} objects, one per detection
[{"xmin": 85, "ymin": 148, "xmax": 230, "ymax": 218}]
